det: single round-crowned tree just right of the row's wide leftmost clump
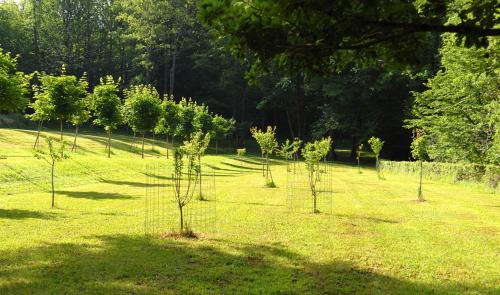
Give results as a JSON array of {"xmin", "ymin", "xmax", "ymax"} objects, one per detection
[{"xmin": 90, "ymin": 76, "xmax": 122, "ymax": 158}]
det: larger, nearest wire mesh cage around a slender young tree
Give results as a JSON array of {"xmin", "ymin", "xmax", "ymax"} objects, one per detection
[{"xmin": 144, "ymin": 163, "xmax": 217, "ymax": 236}]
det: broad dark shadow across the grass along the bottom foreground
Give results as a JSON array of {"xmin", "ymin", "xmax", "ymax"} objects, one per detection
[{"xmin": 0, "ymin": 235, "xmax": 498, "ymax": 294}]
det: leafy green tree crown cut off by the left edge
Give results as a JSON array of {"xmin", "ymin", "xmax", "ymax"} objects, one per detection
[{"xmin": 0, "ymin": 48, "xmax": 29, "ymax": 112}]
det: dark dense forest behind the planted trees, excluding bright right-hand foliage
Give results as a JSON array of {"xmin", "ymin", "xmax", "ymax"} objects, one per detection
[{"xmin": 0, "ymin": 0, "xmax": 430, "ymax": 158}]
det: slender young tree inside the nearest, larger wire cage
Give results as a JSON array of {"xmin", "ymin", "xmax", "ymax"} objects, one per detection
[{"xmin": 172, "ymin": 148, "xmax": 199, "ymax": 233}]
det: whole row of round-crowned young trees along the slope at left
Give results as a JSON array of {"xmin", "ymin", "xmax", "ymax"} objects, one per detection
[{"xmin": 27, "ymin": 70, "xmax": 235, "ymax": 157}]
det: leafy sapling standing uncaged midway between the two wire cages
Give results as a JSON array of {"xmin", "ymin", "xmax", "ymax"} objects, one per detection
[{"xmin": 250, "ymin": 126, "xmax": 278, "ymax": 187}]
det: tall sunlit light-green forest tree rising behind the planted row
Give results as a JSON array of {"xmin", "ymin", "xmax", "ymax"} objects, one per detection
[{"xmin": 119, "ymin": 0, "xmax": 201, "ymax": 95}]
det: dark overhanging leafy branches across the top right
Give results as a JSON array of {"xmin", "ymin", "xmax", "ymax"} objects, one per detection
[{"xmin": 200, "ymin": 0, "xmax": 500, "ymax": 72}]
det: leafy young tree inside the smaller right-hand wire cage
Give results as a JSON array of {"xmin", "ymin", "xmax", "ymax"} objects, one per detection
[{"xmin": 302, "ymin": 137, "xmax": 332, "ymax": 213}]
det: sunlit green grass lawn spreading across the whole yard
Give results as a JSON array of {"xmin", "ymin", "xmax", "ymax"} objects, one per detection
[{"xmin": 0, "ymin": 129, "xmax": 500, "ymax": 294}]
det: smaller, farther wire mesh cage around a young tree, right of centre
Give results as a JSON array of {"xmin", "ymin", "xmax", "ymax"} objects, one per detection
[{"xmin": 286, "ymin": 161, "xmax": 333, "ymax": 214}]
